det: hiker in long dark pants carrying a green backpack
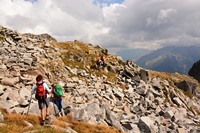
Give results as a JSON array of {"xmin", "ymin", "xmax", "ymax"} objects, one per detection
[{"xmin": 51, "ymin": 84, "xmax": 65, "ymax": 116}]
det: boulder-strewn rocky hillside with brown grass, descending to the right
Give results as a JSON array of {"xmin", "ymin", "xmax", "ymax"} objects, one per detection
[{"xmin": 0, "ymin": 27, "xmax": 200, "ymax": 133}]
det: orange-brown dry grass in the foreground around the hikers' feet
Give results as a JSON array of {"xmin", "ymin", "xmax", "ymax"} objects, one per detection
[{"xmin": 0, "ymin": 109, "xmax": 120, "ymax": 133}]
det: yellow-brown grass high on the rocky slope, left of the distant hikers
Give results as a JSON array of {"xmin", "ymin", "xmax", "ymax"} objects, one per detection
[{"xmin": 49, "ymin": 41, "xmax": 118, "ymax": 83}]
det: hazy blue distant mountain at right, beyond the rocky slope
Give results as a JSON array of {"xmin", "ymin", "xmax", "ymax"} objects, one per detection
[{"xmin": 135, "ymin": 44, "xmax": 200, "ymax": 74}]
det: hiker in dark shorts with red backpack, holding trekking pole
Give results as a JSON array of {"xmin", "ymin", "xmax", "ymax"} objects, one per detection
[{"xmin": 31, "ymin": 75, "xmax": 51, "ymax": 125}]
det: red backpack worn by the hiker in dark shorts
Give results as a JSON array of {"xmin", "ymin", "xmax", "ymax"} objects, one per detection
[{"xmin": 35, "ymin": 82, "xmax": 46, "ymax": 100}]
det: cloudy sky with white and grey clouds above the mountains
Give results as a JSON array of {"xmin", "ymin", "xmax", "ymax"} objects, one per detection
[{"xmin": 0, "ymin": 0, "xmax": 200, "ymax": 53}]
